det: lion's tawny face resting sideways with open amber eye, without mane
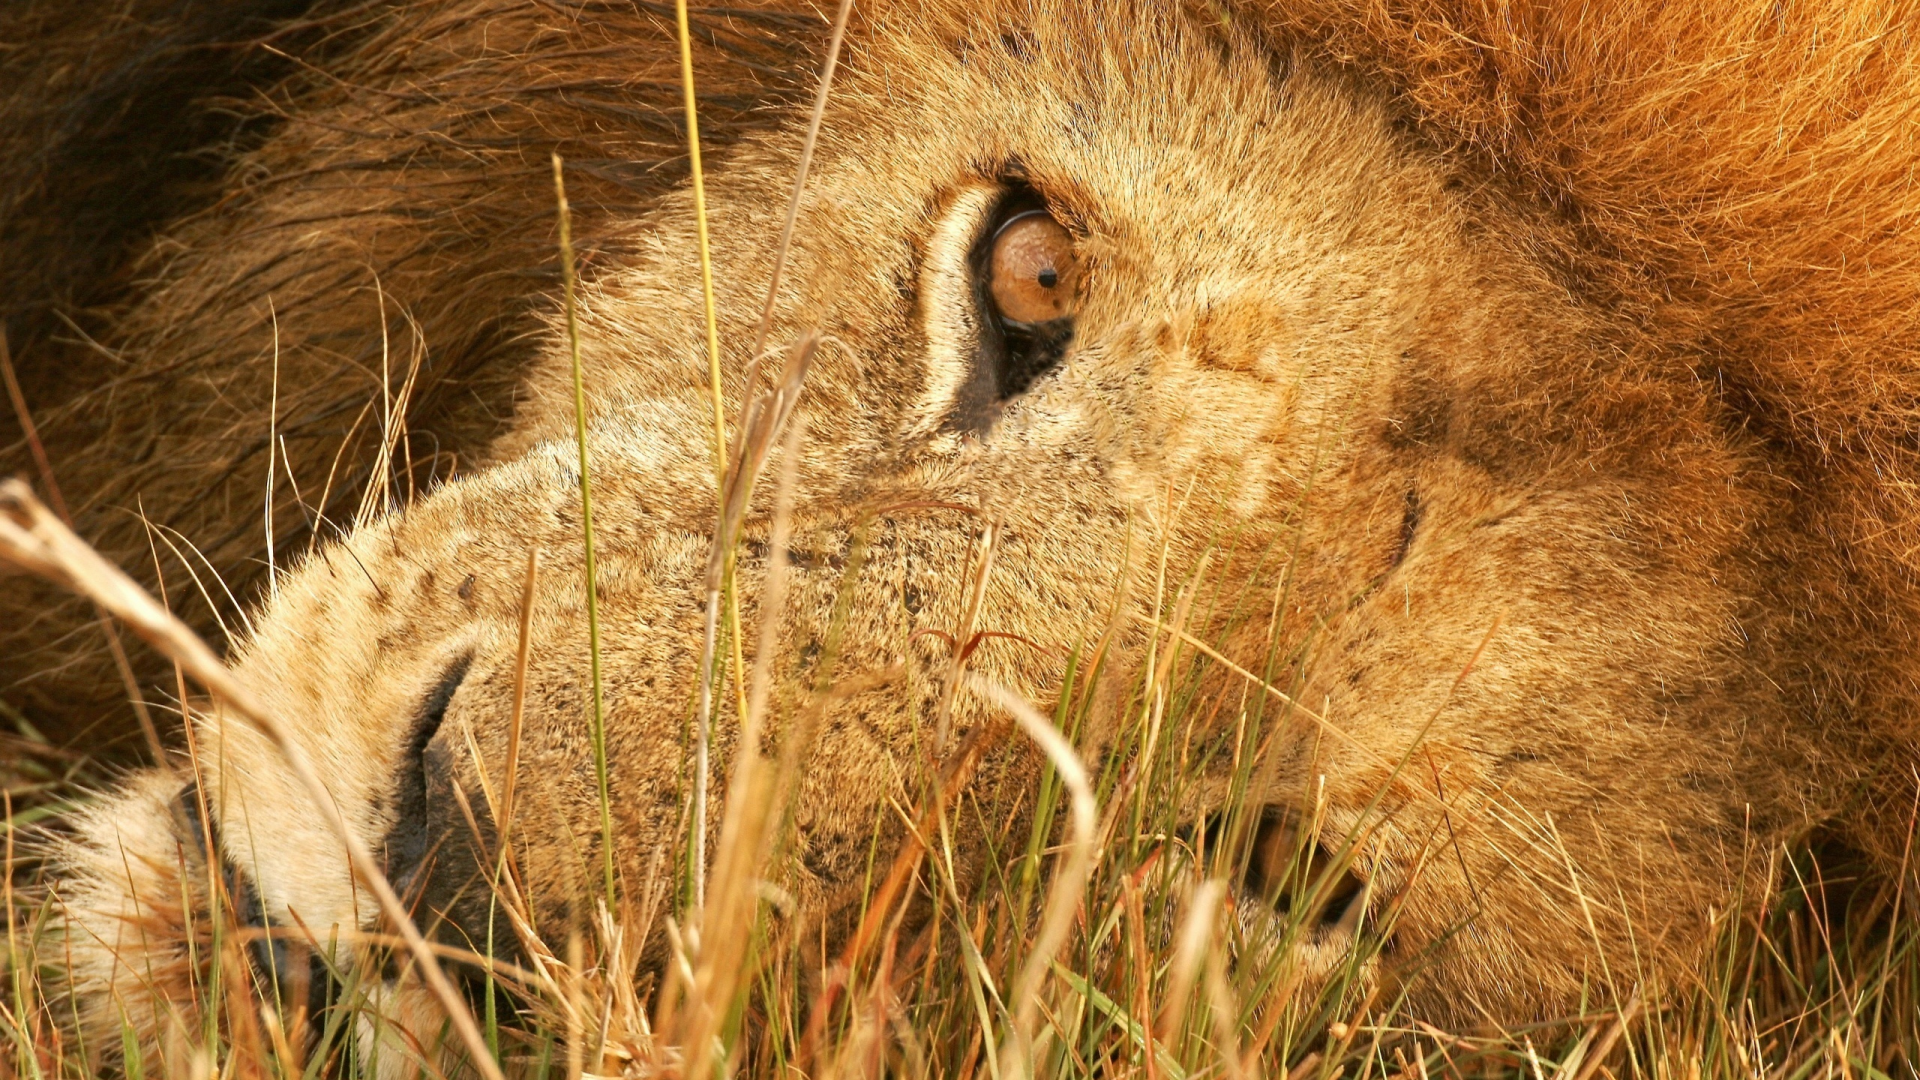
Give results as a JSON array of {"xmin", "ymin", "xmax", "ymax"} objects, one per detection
[{"xmin": 205, "ymin": 6, "xmax": 1797, "ymax": 1015}]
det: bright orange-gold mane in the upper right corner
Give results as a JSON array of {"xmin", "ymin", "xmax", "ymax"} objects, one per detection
[{"xmin": 1258, "ymin": 0, "xmax": 1920, "ymax": 805}]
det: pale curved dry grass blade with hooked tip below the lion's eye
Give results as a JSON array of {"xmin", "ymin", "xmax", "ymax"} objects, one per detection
[{"xmin": 968, "ymin": 675, "xmax": 1100, "ymax": 1076}]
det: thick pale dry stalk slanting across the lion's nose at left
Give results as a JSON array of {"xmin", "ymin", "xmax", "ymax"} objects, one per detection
[{"xmin": 0, "ymin": 480, "xmax": 505, "ymax": 1080}]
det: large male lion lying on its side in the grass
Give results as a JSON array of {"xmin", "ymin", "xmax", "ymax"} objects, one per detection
[{"xmin": 6, "ymin": 0, "xmax": 1920, "ymax": 1045}]
